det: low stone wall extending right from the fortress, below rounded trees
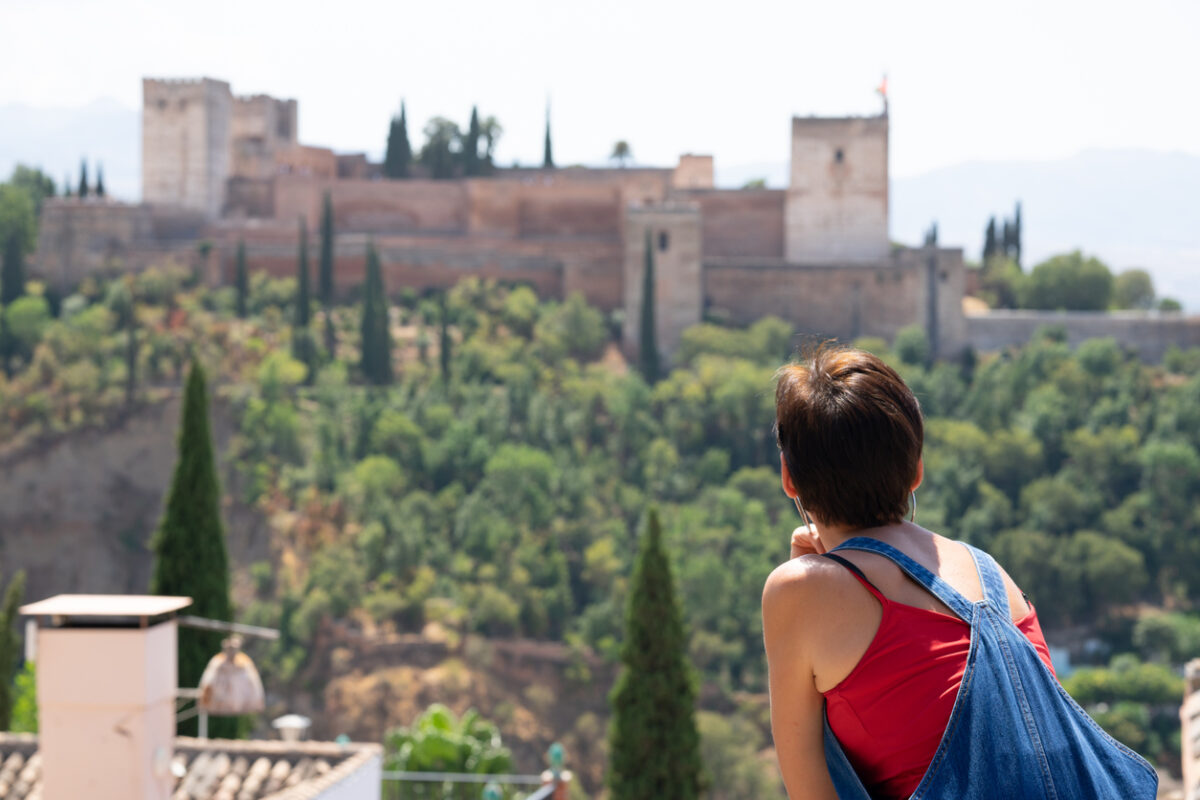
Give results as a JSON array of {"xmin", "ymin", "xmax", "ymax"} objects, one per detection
[{"xmin": 966, "ymin": 311, "xmax": 1200, "ymax": 361}]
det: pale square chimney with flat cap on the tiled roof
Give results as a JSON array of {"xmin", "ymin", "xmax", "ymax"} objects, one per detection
[{"xmin": 20, "ymin": 595, "xmax": 192, "ymax": 800}]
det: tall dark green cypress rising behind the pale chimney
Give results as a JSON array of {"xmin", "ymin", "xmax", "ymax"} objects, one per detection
[{"xmin": 150, "ymin": 361, "xmax": 234, "ymax": 736}]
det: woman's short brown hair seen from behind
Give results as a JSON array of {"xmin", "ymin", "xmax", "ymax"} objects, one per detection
[{"xmin": 775, "ymin": 344, "xmax": 925, "ymax": 528}]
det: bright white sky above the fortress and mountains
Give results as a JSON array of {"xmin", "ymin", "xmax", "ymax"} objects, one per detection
[{"xmin": 0, "ymin": 0, "xmax": 1200, "ymax": 178}]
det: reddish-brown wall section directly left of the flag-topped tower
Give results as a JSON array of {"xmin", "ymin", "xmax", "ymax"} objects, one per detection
[{"xmin": 689, "ymin": 190, "xmax": 787, "ymax": 258}]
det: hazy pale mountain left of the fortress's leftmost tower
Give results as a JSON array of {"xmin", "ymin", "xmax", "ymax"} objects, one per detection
[{"xmin": 0, "ymin": 100, "xmax": 142, "ymax": 200}]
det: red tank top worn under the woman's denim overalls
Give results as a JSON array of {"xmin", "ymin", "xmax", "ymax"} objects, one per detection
[{"xmin": 824, "ymin": 556, "xmax": 1054, "ymax": 800}]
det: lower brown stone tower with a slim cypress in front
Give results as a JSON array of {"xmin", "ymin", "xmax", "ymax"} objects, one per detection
[{"xmin": 622, "ymin": 201, "xmax": 703, "ymax": 364}]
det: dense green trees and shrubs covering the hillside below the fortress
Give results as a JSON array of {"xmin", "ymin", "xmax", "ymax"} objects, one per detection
[{"xmin": 0, "ymin": 267, "xmax": 1200, "ymax": 777}]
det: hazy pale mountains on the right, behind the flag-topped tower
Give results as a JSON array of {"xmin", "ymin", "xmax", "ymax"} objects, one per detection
[{"xmin": 718, "ymin": 150, "xmax": 1200, "ymax": 311}]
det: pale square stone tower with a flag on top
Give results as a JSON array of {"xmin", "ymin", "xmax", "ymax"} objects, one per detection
[{"xmin": 785, "ymin": 115, "xmax": 889, "ymax": 264}]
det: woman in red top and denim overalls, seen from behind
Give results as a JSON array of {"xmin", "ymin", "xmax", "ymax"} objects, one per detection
[{"xmin": 762, "ymin": 347, "xmax": 1158, "ymax": 800}]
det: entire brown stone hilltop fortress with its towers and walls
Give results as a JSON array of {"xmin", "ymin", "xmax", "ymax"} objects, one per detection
[{"xmin": 36, "ymin": 78, "xmax": 1200, "ymax": 357}]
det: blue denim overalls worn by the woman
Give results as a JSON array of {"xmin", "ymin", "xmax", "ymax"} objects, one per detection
[{"xmin": 824, "ymin": 536, "xmax": 1158, "ymax": 800}]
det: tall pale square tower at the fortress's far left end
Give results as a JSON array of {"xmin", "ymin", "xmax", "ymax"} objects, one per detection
[{"xmin": 142, "ymin": 78, "xmax": 233, "ymax": 218}]
